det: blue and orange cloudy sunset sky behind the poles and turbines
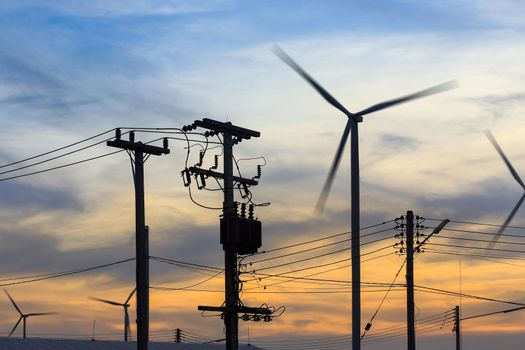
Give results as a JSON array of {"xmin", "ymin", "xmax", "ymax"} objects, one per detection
[{"xmin": 0, "ymin": 0, "xmax": 525, "ymax": 350}]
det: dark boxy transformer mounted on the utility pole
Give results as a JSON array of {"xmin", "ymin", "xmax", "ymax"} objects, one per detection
[{"xmin": 221, "ymin": 217, "xmax": 262, "ymax": 255}]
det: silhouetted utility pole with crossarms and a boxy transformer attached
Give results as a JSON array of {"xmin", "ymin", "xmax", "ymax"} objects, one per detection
[{"xmin": 183, "ymin": 118, "xmax": 271, "ymax": 350}]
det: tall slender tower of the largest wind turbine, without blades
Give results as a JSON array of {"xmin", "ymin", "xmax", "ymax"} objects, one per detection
[{"xmin": 350, "ymin": 120, "xmax": 361, "ymax": 350}]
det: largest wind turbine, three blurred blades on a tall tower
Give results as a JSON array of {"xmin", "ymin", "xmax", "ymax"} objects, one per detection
[{"xmin": 272, "ymin": 45, "xmax": 457, "ymax": 350}]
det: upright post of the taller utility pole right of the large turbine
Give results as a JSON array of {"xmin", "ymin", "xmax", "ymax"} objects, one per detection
[{"xmin": 406, "ymin": 210, "xmax": 416, "ymax": 350}]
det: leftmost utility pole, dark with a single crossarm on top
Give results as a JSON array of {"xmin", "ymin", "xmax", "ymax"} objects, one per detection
[{"xmin": 107, "ymin": 129, "xmax": 170, "ymax": 350}]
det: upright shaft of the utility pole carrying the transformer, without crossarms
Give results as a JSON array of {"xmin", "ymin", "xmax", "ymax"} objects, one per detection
[{"xmin": 223, "ymin": 130, "xmax": 239, "ymax": 350}]
